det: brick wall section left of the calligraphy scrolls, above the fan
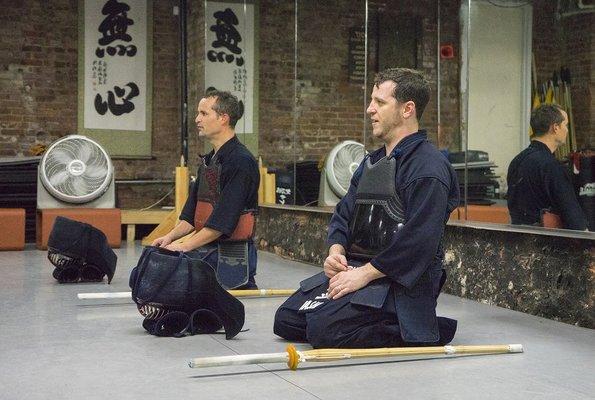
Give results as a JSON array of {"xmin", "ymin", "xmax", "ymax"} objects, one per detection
[{"xmin": 0, "ymin": 0, "xmax": 77, "ymax": 157}]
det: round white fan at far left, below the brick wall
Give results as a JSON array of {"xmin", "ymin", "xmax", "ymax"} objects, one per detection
[{"xmin": 40, "ymin": 135, "xmax": 112, "ymax": 203}]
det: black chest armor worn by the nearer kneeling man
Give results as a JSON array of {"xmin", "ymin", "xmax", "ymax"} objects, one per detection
[{"xmin": 347, "ymin": 157, "xmax": 405, "ymax": 262}]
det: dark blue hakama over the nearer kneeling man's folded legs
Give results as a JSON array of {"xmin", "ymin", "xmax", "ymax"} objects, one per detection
[{"xmin": 273, "ymin": 271, "xmax": 457, "ymax": 348}]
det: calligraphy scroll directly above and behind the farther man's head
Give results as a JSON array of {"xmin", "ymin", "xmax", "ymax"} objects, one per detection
[{"xmin": 205, "ymin": 1, "xmax": 256, "ymax": 138}]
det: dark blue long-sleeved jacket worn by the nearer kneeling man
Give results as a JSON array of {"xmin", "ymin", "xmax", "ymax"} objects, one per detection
[{"xmin": 327, "ymin": 130, "xmax": 459, "ymax": 289}]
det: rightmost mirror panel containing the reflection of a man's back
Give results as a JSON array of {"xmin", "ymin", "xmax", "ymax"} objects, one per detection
[{"xmin": 458, "ymin": 0, "xmax": 595, "ymax": 230}]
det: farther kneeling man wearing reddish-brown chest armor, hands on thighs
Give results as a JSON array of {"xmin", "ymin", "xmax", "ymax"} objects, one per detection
[{"xmin": 152, "ymin": 90, "xmax": 260, "ymax": 289}]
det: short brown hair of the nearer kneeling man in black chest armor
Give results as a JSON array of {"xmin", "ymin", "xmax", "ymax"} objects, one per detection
[{"xmin": 374, "ymin": 68, "xmax": 430, "ymax": 121}]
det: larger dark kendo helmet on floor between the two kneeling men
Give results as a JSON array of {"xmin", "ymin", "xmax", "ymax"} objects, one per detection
[{"xmin": 129, "ymin": 246, "xmax": 244, "ymax": 339}]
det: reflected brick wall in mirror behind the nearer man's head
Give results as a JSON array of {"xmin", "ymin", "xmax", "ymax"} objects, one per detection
[{"xmin": 260, "ymin": 0, "xmax": 460, "ymax": 169}]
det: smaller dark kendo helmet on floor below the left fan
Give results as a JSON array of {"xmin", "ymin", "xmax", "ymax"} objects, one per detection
[{"xmin": 48, "ymin": 217, "xmax": 118, "ymax": 283}]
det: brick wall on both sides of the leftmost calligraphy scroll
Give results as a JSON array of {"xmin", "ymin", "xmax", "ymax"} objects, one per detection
[{"xmin": 0, "ymin": 0, "xmax": 180, "ymax": 207}]
